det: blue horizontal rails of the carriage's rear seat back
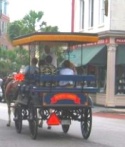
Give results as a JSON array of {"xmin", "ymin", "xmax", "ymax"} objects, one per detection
[{"xmin": 29, "ymin": 75, "xmax": 98, "ymax": 92}]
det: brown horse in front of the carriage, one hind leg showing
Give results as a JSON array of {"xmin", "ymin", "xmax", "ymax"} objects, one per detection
[{"xmin": 4, "ymin": 76, "xmax": 19, "ymax": 127}]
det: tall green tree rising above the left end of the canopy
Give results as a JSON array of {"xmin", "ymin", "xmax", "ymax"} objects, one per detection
[{"xmin": 8, "ymin": 10, "xmax": 46, "ymax": 40}]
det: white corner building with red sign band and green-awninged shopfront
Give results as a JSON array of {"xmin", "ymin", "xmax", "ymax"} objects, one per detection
[{"xmin": 71, "ymin": 0, "xmax": 125, "ymax": 107}]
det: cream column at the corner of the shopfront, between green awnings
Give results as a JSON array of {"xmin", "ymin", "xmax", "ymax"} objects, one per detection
[{"xmin": 105, "ymin": 38, "xmax": 117, "ymax": 107}]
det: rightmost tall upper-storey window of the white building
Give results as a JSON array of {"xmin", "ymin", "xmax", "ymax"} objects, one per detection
[{"xmin": 99, "ymin": 0, "xmax": 105, "ymax": 25}]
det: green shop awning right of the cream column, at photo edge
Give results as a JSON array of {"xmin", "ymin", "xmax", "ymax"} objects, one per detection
[{"xmin": 116, "ymin": 45, "xmax": 125, "ymax": 65}]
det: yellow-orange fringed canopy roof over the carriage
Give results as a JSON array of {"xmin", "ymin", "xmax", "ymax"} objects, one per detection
[{"xmin": 12, "ymin": 32, "xmax": 98, "ymax": 46}]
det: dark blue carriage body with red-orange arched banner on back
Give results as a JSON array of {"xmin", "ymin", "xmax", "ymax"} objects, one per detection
[{"xmin": 22, "ymin": 75, "xmax": 98, "ymax": 121}]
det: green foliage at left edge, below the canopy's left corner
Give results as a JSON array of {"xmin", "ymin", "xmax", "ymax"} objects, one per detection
[{"xmin": 0, "ymin": 48, "xmax": 29, "ymax": 76}]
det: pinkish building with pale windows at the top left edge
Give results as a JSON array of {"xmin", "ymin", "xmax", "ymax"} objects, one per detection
[{"xmin": 0, "ymin": 0, "xmax": 12, "ymax": 49}]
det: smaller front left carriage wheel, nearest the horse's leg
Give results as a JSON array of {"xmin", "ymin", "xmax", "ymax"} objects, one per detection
[{"xmin": 15, "ymin": 105, "xmax": 22, "ymax": 133}]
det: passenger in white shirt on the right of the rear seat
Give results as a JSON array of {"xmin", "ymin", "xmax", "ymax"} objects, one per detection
[{"xmin": 59, "ymin": 60, "xmax": 76, "ymax": 86}]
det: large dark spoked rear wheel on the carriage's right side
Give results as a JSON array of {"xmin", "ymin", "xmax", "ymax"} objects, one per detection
[{"xmin": 81, "ymin": 108, "xmax": 92, "ymax": 139}]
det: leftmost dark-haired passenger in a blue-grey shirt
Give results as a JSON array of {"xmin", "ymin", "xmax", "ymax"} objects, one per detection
[{"xmin": 22, "ymin": 58, "xmax": 39, "ymax": 75}]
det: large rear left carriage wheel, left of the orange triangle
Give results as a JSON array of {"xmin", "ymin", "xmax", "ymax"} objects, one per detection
[{"xmin": 29, "ymin": 105, "xmax": 38, "ymax": 139}]
